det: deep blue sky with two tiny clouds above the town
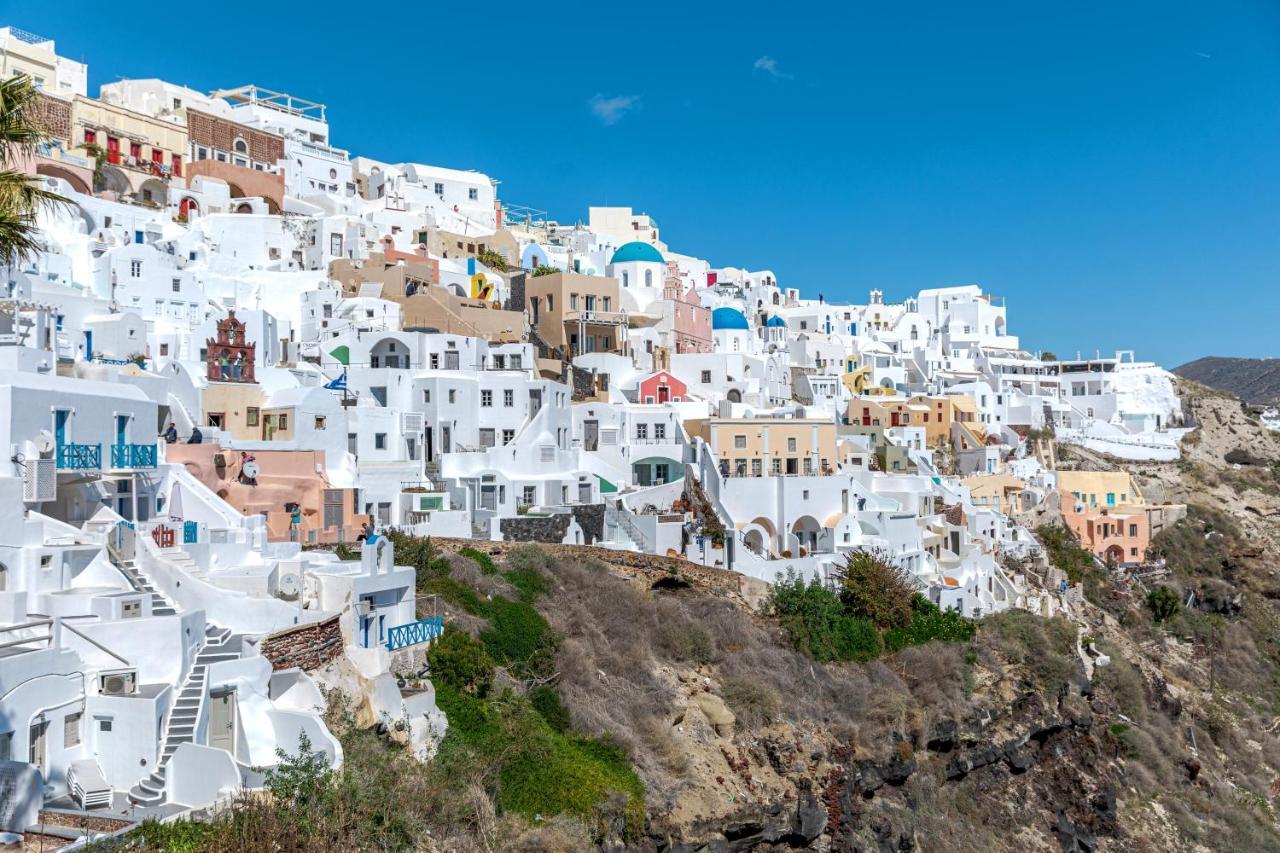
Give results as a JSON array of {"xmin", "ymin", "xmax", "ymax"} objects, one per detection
[{"xmin": 12, "ymin": 0, "xmax": 1280, "ymax": 366}]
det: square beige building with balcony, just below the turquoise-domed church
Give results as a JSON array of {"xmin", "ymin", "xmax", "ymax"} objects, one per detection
[{"xmin": 525, "ymin": 273, "xmax": 627, "ymax": 359}]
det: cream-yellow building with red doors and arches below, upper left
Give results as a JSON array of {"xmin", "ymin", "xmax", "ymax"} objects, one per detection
[{"xmin": 70, "ymin": 95, "xmax": 187, "ymax": 199}]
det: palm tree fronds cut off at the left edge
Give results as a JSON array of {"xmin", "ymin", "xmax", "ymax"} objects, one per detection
[{"xmin": 0, "ymin": 74, "xmax": 70, "ymax": 266}]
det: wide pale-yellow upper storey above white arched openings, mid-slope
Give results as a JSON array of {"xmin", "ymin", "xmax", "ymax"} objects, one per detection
[{"xmin": 701, "ymin": 418, "xmax": 837, "ymax": 476}]
